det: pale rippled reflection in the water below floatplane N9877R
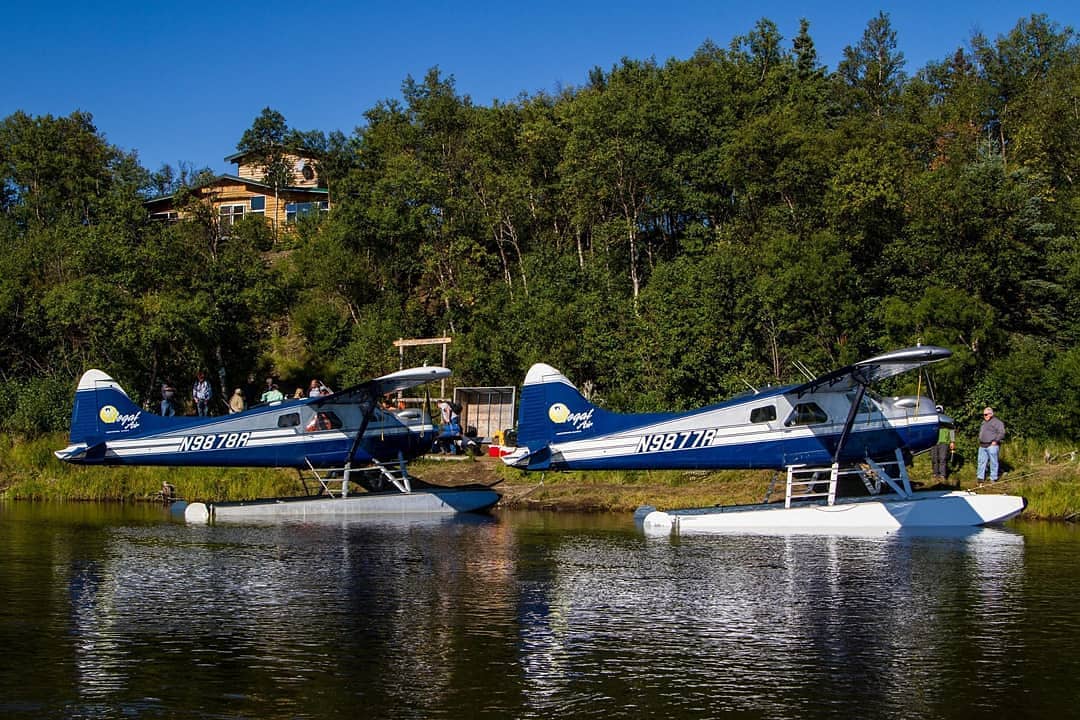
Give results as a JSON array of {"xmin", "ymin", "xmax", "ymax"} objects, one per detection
[{"xmin": 509, "ymin": 530, "xmax": 1024, "ymax": 717}]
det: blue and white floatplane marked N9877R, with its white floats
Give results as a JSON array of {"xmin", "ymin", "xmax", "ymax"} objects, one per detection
[{"xmin": 503, "ymin": 345, "xmax": 1024, "ymax": 530}]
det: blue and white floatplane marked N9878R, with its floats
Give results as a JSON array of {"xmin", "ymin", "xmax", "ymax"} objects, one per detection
[{"xmin": 56, "ymin": 367, "xmax": 498, "ymax": 516}]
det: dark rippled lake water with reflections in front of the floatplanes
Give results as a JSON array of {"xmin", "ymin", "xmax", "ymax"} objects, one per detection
[{"xmin": 0, "ymin": 503, "xmax": 1080, "ymax": 719}]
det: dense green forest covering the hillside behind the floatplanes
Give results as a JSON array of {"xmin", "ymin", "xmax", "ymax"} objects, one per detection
[{"xmin": 0, "ymin": 14, "xmax": 1080, "ymax": 438}]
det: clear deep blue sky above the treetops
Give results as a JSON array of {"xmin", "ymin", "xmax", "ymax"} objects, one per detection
[{"xmin": 0, "ymin": 0, "xmax": 1080, "ymax": 172}]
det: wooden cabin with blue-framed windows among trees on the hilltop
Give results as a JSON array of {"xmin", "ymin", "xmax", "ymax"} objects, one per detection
[{"xmin": 145, "ymin": 152, "xmax": 329, "ymax": 232}]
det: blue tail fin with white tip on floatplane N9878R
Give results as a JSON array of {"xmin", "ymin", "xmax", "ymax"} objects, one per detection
[{"xmin": 55, "ymin": 370, "xmax": 167, "ymax": 462}]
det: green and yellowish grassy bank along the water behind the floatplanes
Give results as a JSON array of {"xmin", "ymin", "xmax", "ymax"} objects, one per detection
[{"xmin": 0, "ymin": 435, "xmax": 1080, "ymax": 520}]
